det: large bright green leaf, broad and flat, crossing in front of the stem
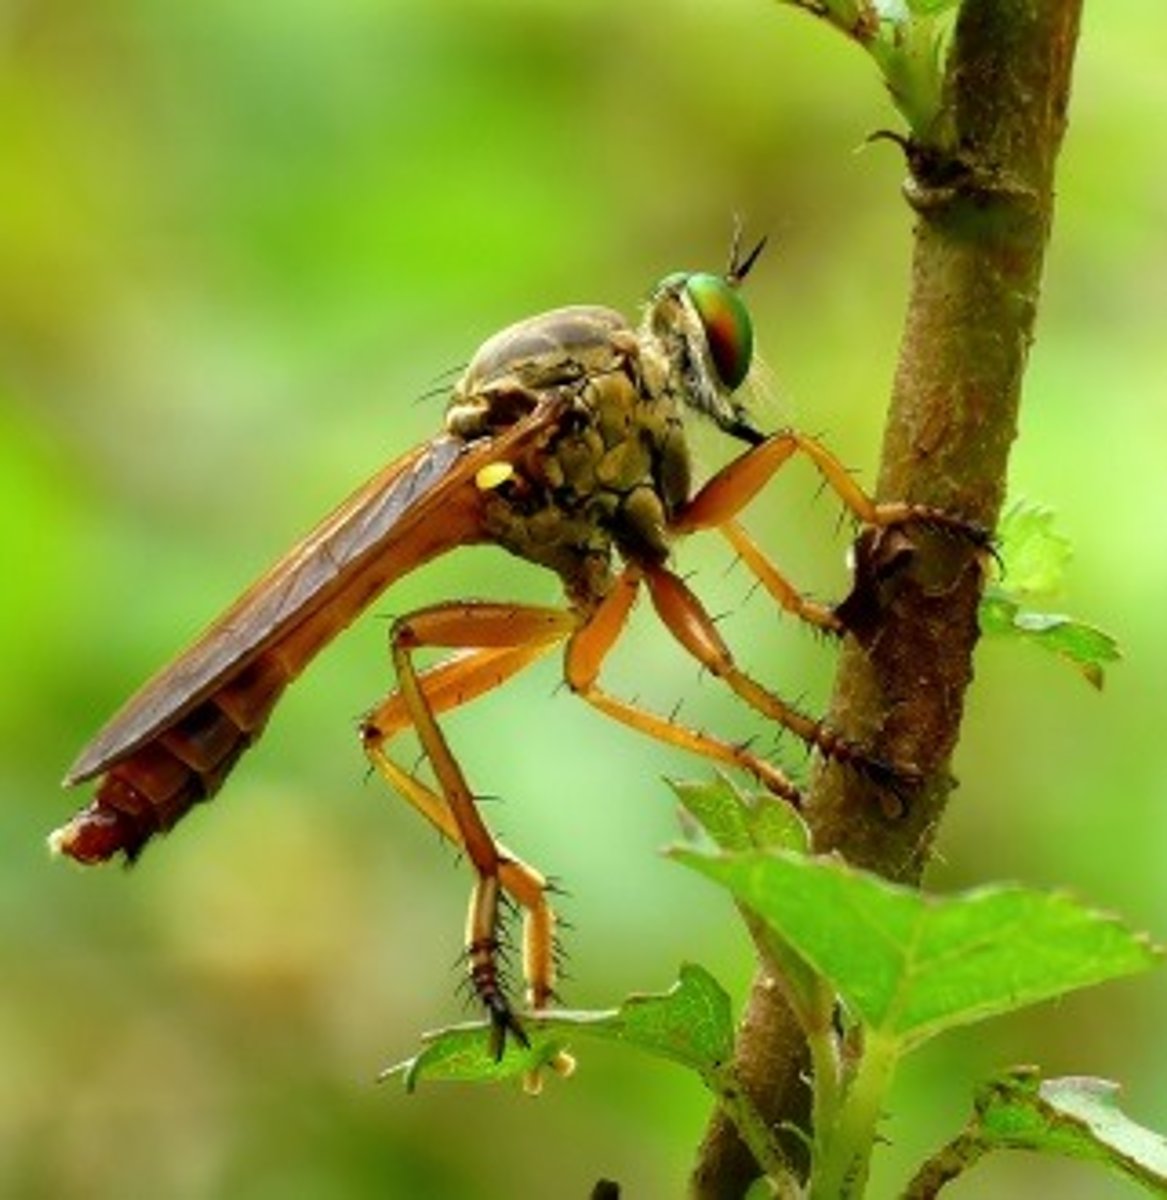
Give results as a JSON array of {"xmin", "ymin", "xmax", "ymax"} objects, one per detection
[{"xmin": 674, "ymin": 848, "xmax": 1160, "ymax": 1049}]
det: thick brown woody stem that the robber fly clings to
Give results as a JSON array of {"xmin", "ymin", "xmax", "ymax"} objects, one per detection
[{"xmin": 692, "ymin": 0, "xmax": 1081, "ymax": 1200}]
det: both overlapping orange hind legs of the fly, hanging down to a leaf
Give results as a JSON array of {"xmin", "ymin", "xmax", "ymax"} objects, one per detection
[{"xmin": 361, "ymin": 602, "xmax": 577, "ymax": 1054}]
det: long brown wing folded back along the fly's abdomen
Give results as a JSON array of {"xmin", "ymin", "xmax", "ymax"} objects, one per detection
[{"xmin": 65, "ymin": 402, "xmax": 557, "ymax": 785}]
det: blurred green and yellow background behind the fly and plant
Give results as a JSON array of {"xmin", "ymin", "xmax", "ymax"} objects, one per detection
[{"xmin": 0, "ymin": 0, "xmax": 1167, "ymax": 1200}]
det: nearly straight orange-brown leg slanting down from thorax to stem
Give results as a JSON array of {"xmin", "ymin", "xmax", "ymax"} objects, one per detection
[{"xmin": 644, "ymin": 565, "xmax": 881, "ymax": 770}]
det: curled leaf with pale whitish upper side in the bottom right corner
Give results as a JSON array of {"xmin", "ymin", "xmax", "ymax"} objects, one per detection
[{"xmin": 976, "ymin": 1068, "xmax": 1167, "ymax": 1194}]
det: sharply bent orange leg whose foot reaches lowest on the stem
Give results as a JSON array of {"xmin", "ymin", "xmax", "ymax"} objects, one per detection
[{"xmin": 564, "ymin": 566, "xmax": 801, "ymax": 804}]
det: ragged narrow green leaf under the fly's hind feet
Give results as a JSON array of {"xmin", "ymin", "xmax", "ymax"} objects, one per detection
[{"xmin": 379, "ymin": 965, "xmax": 734, "ymax": 1091}]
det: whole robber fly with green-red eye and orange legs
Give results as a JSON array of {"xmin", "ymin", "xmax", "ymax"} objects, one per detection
[{"xmin": 52, "ymin": 239, "xmax": 974, "ymax": 1052}]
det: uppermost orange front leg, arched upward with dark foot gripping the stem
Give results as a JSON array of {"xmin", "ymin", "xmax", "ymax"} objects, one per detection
[{"xmin": 671, "ymin": 430, "xmax": 983, "ymax": 532}]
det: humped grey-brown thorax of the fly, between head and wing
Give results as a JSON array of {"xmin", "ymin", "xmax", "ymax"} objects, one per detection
[{"xmin": 447, "ymin": 306, "xmax": 689, "ymax": 608}]
